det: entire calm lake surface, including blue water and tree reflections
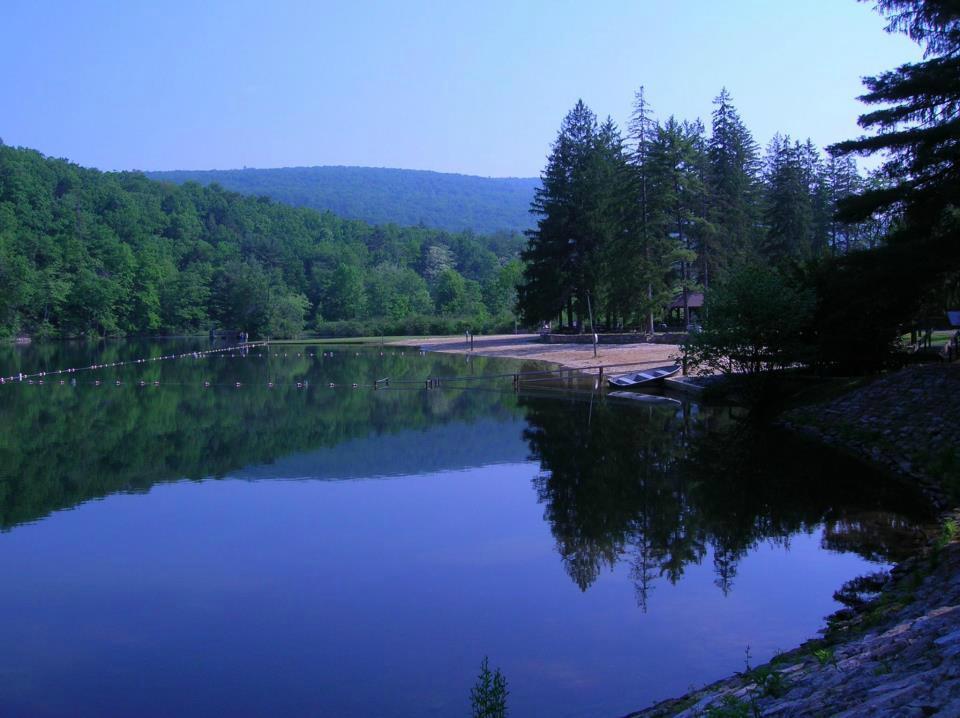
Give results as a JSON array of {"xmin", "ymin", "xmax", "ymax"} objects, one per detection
[{"xmin": 0, "ymin": 342, "xmax": 925, "ymax": 718}]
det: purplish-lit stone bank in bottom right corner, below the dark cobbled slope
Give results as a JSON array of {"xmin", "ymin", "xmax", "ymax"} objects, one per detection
[{"xmin": 630, "ymin": 524, "xmax": 960, "ymax": 718}]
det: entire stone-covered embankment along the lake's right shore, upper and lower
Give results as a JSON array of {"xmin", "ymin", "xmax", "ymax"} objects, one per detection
[{"xmin": 628, "ymin": 365, "xmax": 960, "ymax": 718}]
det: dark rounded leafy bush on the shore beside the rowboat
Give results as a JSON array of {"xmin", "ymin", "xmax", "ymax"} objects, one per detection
[{"xmin": 684, "ymin": 264, "xmax": 814, "ymax": 373}]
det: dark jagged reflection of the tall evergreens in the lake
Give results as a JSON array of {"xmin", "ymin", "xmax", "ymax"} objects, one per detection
[{"xmin": 521, "ymin": 397, "xmax": 927, "ymax": 610}]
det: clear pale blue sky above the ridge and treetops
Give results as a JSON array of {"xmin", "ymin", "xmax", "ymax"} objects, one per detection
[{"xmin": 0, "ymin": 0, "xmax": 920, "ymax": 176}]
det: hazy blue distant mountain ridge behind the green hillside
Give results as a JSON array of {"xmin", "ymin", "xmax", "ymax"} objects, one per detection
[{"xmin": 144, "ymin": 166, "xmax": 540, "ymax": 234}]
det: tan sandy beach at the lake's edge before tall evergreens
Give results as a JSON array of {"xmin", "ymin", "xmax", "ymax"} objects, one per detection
[{"xmin": 396, "ymin": 334, "xmax": 680, "ymax": 373}]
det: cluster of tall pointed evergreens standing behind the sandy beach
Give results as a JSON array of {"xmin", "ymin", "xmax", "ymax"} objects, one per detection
[{"xmin": 520, "ymin": 89, "xmax": 886, "ymax": 331}]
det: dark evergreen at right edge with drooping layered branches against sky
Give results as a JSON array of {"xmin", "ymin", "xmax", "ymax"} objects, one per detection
[{"xmin": 817, "ymin": 0, "xmax": 960, "ymax": 363}]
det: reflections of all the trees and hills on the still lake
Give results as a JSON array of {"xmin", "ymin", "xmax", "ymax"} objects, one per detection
[{"xmin": 0, "ymin": 342, "xmax": 922, "ymax": 609}]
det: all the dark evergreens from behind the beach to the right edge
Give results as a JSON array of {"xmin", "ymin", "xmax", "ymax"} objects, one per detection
[{"xmin": 519, "ymin": 0, "xmax": 960, "ymax": 370}]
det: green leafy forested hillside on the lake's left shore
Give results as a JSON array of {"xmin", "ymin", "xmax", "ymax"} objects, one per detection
[{"xmin": 0, "ymin": 145, "xmax": 522, "ymax": 337}]
